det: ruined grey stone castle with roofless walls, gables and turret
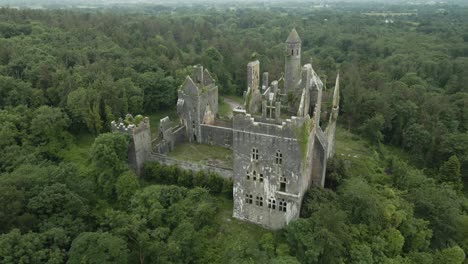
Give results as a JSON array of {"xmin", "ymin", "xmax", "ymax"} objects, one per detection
[{"xmin": 115, "ymin": 29, "xmax": 339, "ymax": 229}]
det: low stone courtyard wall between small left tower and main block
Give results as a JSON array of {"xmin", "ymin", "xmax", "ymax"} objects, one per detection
[{"xmin": 149, "ymin": 153, "xmax": 233, "ymax": 179}]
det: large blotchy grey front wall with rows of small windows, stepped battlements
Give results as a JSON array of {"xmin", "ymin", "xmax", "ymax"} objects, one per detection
[{"xmin": 233, "ymin": 119, "xmax": 302, "ymax": 229}]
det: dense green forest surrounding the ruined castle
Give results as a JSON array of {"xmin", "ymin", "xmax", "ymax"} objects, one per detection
[{"xmin": 0, "ymin": 5, "xmax": 468, "ymax": 264}]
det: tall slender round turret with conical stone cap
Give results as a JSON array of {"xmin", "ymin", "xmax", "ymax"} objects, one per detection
[{"xmin": 284, "ymin": 28, "xmax": 301, "ymax": 91}]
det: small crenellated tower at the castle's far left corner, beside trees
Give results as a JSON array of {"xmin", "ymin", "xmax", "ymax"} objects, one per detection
[{"xmin": 111, "ymin": 117, "xmax": 151, "ymax": 176}]
